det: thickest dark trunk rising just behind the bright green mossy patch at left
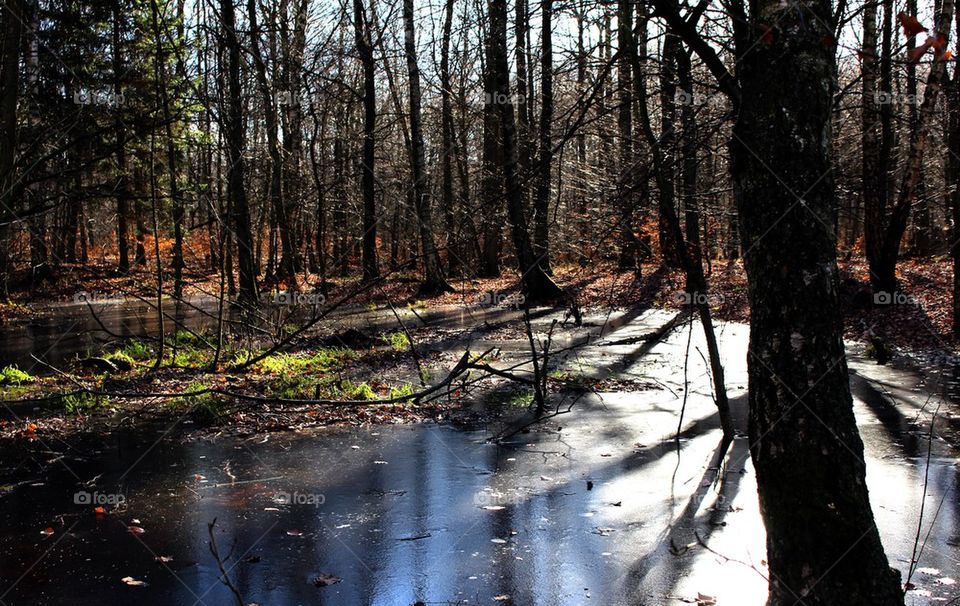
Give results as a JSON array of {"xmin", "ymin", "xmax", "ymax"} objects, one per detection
[{"xmin": 220, "ymin": 0, "xmax": 257, "ymax": 305}]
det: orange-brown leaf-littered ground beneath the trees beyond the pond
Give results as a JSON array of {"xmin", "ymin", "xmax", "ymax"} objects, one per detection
[{"xmin": 0, "ymin": 257, "xmax": 960, "ymax": 354}]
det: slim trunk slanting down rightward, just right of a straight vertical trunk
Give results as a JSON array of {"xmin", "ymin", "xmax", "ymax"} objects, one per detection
[{"xmin": 403, "ymin": 0, "xmax": 453, "ymax": 294}]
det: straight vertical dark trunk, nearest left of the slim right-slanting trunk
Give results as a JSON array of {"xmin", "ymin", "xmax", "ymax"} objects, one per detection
[{"xmin": 353, "ymin": 0, "xmax": 380, "ymax": 280}]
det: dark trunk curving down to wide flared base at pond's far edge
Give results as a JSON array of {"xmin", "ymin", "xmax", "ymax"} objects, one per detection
[{"xmin": 488, "ymin": 0, "xmax": 562, "ymax": 302}]
